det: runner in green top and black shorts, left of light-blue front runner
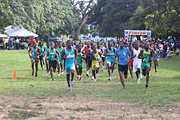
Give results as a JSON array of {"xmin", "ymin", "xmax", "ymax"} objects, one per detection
[{"xmin": 46, "ymin": 43, "xmax": 59, "ymax": 81}]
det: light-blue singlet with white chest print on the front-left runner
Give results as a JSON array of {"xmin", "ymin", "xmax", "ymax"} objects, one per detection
[{"xmin": 65, "ymin": 48, "xmax": 75, "ymax": 66}]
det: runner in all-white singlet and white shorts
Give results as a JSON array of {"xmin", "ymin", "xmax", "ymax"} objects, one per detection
[{"xmin": 131, "ymin": 41, "xmax": 142, "ymax": 83}]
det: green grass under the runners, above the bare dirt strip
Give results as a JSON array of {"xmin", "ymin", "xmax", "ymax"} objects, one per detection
[{"xmin": 0, "ymin": 50, "xmax": 180, "ymax": 108}]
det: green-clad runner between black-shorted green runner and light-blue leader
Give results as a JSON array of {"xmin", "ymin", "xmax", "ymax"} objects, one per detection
[{"xmin": 57, "ymin": 43, "xmax": 64, "ymax": 77}]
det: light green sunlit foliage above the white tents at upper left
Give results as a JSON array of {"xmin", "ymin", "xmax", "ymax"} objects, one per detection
[{"xmin": 0, "ymin": 0, "xmax": 77, "ymax": 35}]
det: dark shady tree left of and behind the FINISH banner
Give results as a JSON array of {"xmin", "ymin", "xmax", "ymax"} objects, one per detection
[{"xmin": 88, "ymin": 0, "xmax": 139, "ymax": 38}]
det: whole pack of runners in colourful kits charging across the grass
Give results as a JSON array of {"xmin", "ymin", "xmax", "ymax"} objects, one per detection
[{"xmin": 28, "ymin": 40, "xmax": 160, "ymax": 91}]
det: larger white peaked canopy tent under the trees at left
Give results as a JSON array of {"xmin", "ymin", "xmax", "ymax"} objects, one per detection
[{"xmin": 5, "ymin": 26, "xmax": 38, "ymax": 37}]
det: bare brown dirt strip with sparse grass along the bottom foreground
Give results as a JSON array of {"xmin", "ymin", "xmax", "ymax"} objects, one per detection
[{"xmin": 0, "ymin": 96, "xmax": 180, "ymax": 120}]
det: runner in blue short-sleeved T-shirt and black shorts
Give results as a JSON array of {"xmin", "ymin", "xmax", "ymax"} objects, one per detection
[{"xmin": 115, "ymin": 41, "xmax": 131, "ymax": 90}]
